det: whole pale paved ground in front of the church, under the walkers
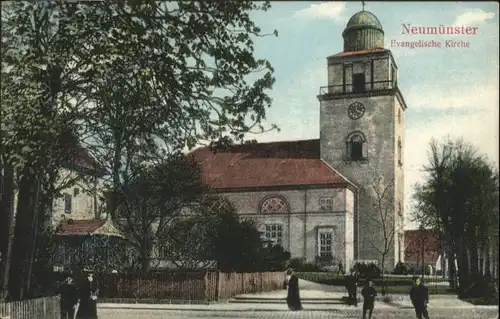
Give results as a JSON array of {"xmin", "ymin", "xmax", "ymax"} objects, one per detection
[{"xmin": 98, "ymin": 280, "xmax": 498, "ymax": 319}]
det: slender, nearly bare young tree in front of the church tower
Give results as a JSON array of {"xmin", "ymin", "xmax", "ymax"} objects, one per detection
[{"xmin": 367, "ymin": 176, "xmax": 404, "ymax": 294}]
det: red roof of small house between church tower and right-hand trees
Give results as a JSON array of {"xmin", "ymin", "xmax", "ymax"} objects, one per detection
[{"xmin": 404, "ymin": 230, "xmax": 441, "ymax": 264}]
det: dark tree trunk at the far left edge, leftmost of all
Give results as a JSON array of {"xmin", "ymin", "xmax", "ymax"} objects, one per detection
[{"xmin": 0, "ymin": 163, "xmax": 15, "ymax": 300}]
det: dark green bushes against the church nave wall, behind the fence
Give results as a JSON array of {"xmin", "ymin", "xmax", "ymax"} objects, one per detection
[{"xmin": 162, "ymin": 197, "xmax": 290, "ymax": 272}]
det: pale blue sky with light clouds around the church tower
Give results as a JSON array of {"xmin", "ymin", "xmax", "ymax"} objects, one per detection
[{"xmin": 242, "ymin": 1, "xmax": 499, "ymax": 228}]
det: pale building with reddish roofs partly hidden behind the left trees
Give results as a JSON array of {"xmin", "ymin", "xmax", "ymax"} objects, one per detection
[{"xmin": 49, "ymin": 147, "xmax": 121, "ymax": 269}]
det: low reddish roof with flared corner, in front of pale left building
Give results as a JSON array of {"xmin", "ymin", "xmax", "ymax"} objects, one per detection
[{"xmin": 56, "ymin": 219, "xmax": 122, "ymax": 237}]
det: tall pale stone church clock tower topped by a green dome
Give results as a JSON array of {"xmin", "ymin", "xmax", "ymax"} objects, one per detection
[{"xmin": 318, "ymin": 9, "xmax": 406, "ymax": 269}]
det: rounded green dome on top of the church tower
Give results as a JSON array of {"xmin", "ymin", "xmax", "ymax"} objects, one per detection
[{"xmin": 342, "ymin": 10, "xmax": 384, "ymax": 51}]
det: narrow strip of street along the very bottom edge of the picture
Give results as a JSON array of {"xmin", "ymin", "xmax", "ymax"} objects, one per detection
[{"xmin": 99, "ymin": 307, "xmax": 498, "ymax": 319}]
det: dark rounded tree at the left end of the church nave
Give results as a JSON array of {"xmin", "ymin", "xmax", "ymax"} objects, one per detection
[{"xmin": 115, "ymin": 153, "xmax": 205, "ymax": 271}]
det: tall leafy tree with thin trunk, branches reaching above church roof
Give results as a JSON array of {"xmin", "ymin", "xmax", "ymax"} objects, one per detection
[{"xmin": 76, "ymin": 1, "xmax": 282, "ymax": 219}]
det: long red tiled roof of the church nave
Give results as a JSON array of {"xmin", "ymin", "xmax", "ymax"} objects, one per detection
[{"xmin": 191, "ymin": 140, "xmax": 349, "ymax": 189}]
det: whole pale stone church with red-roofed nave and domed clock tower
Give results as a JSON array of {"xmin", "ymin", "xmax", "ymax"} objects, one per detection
[{"xmin": 191, "ymin": 10, "xmax": 406, "ymax": 269}]
